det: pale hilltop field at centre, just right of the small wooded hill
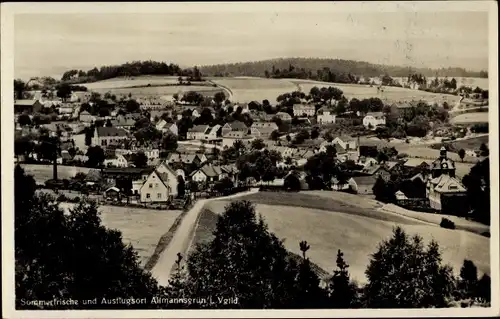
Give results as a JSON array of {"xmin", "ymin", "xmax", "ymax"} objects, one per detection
[{"xmin": 212, "ymin": 77, "xmax": 298, "ymax": 104}]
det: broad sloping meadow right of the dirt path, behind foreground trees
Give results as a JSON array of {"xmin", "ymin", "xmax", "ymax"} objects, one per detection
[{"xmin": 194, "ymin": 193, "xmax": 490, "ymax": 283}]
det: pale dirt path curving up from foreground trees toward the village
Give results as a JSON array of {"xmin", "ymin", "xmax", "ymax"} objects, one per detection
[{"xmin": 151, "ymin": 188, "xmax": 258, "ymax": 286}]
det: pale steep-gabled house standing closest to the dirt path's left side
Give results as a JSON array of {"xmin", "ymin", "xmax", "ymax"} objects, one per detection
[{"xmin": 139, "ymin": 169, "xmax": 178, "ymax": 203}]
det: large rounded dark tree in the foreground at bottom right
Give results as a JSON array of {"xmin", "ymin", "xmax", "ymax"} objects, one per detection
[{"xmin": 364, "ymin": 227, "xmax": 454, "ymax": 308}]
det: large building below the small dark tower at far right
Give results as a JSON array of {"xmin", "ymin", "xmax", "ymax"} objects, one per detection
[{"xmin": 426, "ymin": 173, "xmax": 469, "ymax": 216}]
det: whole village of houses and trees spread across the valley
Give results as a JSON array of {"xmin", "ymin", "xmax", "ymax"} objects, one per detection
[{"xmin": 14, "ymin": 76, "xmax": 488, "ymax": 216}]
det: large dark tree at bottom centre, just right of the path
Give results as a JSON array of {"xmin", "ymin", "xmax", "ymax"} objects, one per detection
[{"xmin": 176, "ymin": 201, "xmax": 324, "ymax": 309}]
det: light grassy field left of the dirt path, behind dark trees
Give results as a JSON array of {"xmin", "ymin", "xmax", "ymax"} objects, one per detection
[{"xmin": 60, "ymin": 203, "xmax": 182, "ymax": 266}]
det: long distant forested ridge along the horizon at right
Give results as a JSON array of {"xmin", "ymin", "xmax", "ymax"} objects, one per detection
[{"xmin": 200, "ymin": 58, "xmax": 488, "ymax": 78}]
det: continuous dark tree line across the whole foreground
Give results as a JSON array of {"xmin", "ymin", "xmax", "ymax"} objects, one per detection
[{"xmin": 14, "ymin": 166, "xmax": 491, "ymax": 309}]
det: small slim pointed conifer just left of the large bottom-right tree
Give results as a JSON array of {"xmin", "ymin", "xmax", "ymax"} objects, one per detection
[{"xmin": 328, "ymin": 249, "xmax": 357, "ymax": 309}]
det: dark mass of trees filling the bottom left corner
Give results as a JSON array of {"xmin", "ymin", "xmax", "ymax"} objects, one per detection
[{"xmin": 14, "ymin": 166, "xmax": 162, "ymax": 310}]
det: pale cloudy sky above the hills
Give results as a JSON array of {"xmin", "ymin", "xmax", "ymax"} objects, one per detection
[{"xmin": 14, "ymin": 9, "xmax": 488, "ymax": 79}]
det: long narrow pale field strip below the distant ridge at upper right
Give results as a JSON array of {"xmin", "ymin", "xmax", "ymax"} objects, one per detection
[{"xmin": 289, "ymin": 79, "xmax": 458, "ymax": 104}]
